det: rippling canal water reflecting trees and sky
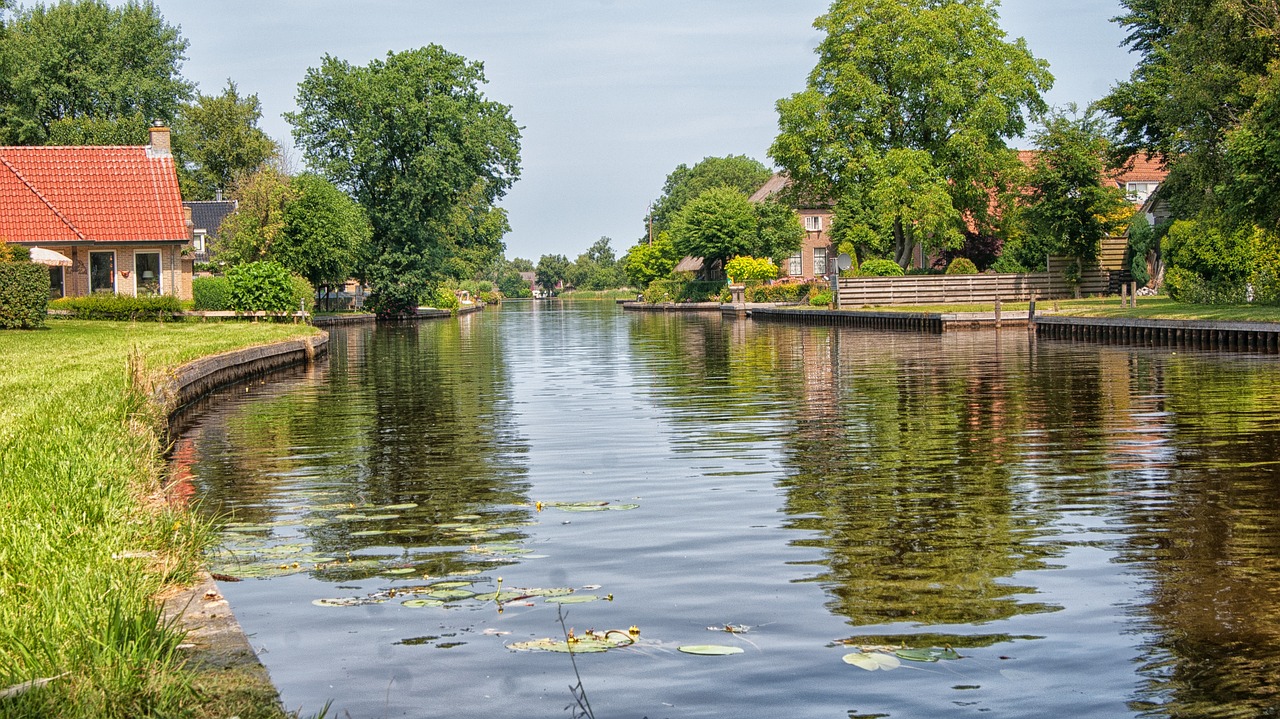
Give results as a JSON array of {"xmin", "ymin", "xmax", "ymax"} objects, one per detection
[{"xmin": 175, "ymin": 303, "xmax": 1280, "ymax": 719}]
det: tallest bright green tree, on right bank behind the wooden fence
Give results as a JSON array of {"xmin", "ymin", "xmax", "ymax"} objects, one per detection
[{"xmin": 769, "ymin": 0, "xmax": 1052, "ymax": 266}]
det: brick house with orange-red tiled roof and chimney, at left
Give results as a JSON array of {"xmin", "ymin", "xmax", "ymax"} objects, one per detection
[{"xmin": 0, "ymin": 127, "xmax": 192, "ymax": 299}]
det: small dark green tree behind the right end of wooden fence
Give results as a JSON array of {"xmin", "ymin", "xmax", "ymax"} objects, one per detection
[{"xmin": 1025, "ymin": 107, "xmax": 1133, "ymax": 267}]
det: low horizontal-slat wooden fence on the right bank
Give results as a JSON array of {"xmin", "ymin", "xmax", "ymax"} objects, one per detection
[{"xmin": 840, "ymin": 263, "xmax": 1110, "ymax": 310}]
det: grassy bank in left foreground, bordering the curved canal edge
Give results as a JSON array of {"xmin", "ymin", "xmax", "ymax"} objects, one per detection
[{"xmin": 0, "ymin": 321, "xmax": 314, "ymax": 719}]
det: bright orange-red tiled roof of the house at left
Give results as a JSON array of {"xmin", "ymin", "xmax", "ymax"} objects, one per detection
[{"xmin": 0, "ymin": 147, "xmax": 188, "ymax": 243}]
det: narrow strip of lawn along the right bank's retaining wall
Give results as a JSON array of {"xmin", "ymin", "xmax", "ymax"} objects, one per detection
[{"xmin": 819, "ymin": 297, "xmax": 1280, "ymax": 322}]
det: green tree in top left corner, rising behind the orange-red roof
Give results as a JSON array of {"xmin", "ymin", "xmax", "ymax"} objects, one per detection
[{"xmin": 0, "ymin": 0, "xmax": 192, "ymax": 145}]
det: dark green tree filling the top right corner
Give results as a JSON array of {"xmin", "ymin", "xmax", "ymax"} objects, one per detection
[{"xmin": 1100, "ymin": 0, "xmax": 1280, "ymax": 218}]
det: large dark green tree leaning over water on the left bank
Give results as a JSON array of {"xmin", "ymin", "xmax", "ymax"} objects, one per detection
[{"xmin": 287, "ymin": 45, "xmax": 520, "ymax": 312}]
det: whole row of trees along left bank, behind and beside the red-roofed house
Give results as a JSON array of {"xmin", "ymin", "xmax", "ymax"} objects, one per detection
[{"xmin": 0, "ymin": 0, "xmax": 520, "ymax": 313}]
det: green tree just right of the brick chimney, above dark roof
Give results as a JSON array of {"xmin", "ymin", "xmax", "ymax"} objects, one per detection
[{"xmin": 174, "ymin": 79, "xmax": 278, "ymax": 200}]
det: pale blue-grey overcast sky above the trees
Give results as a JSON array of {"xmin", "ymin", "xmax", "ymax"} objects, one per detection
[{"xmin": 156, "ymin": 0, "xmax": 1134, "ymax": 262}]
